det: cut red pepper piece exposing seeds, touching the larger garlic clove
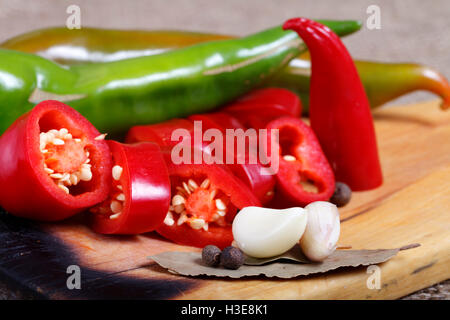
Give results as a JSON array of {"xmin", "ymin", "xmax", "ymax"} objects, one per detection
[{"xmin": 156, "ymin": 152, "xmax": 261, "ymax": 249}]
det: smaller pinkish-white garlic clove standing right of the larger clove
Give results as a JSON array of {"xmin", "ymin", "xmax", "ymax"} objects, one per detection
[{"xmin": 300, "ymin": 201, "xmax": 341, "ymax": 261}]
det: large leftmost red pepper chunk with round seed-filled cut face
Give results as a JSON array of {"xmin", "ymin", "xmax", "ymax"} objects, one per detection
[{"xmin": 0, "ymin": 100, "xmax": 111, "ymax": 221}]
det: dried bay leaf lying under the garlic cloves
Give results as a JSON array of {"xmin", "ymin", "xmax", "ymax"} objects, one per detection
[{"xmin": 150, "ymin": 245, "xmax": 417, "ymax": 279}]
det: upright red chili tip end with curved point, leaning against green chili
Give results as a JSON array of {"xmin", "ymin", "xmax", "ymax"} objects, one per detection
[{"xmin": 283, "ymin": 18, "xmax": 383, "ymax": 191}]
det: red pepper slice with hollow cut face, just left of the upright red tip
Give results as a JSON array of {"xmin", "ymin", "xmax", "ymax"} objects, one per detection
[{"xmin": 267, "ymin": 117, "xmax": 335, "ymax": 207}]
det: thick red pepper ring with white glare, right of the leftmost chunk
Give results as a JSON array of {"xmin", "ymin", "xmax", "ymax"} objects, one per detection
[{"xmin": 90, "ymin": 141, "xmax": 170, "ymax": 234}]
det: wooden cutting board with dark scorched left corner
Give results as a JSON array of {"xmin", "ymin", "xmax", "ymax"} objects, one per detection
[{"xmin": 0, "ymin": 101, "xmax": 450, "ymax": 299}]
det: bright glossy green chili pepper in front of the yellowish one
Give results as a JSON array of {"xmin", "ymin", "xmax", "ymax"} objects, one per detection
[{"xmin": 0, "ymin": 22, "xmax": 359, "ymax": 133}]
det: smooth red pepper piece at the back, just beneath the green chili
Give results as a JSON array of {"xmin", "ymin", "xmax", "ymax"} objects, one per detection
[{"xmin": 223, "ymin": 88, "xmax": 302, "ymax": 129}]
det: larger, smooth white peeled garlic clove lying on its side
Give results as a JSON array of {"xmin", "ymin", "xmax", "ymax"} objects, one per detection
[{"xmin": 232, "ymin": 207, "xmax": 307, "ymax": 258}]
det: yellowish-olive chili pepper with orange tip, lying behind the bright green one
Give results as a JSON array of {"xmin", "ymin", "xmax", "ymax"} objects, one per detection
[{"xmin": 0, "ymin": 21, "xmax": 450, "ymax": 112}]
